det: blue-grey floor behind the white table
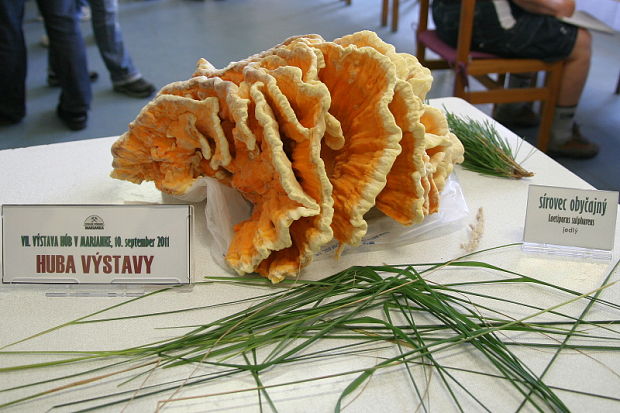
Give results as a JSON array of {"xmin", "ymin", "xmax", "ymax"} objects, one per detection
[{"xmin": 0, "ymin": 0, "xmax": 620, "ymax": 190}]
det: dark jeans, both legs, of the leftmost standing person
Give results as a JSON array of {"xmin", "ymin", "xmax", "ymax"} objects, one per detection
[{"xmin": 0, "ymin": 0, "xmax": 92, "ymax": 121}]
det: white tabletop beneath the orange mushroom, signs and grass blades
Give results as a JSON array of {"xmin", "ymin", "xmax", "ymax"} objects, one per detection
[{"xmin": 0, "ymin": 98, "xmax": 620, "ymax": 412}]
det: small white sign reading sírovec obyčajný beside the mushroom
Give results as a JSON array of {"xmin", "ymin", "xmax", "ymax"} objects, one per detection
[{"xmin": 523, "ymin": 185, "xmax": 618, "ymax": 251}]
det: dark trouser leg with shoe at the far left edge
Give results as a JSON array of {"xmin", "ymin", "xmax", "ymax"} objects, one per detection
[{"xmin": 0, "ymin": 0, "xmax": 27, "ymax": 124}]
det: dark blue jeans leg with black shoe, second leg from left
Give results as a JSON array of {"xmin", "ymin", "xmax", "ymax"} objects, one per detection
[{"xmin": 37, "ymin": 0, "xmax": 92, "ymax": 129}]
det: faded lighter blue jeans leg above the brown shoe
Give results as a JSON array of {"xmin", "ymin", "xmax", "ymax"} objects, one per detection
[{"xmin": 88, "ymin": 0, "xmax": 141, "ymax": 85}]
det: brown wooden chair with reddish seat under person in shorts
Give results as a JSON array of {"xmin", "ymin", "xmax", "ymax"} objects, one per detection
[{"xmin": 416, "ymin": 0, "xmax": 564, "ymax": 152}]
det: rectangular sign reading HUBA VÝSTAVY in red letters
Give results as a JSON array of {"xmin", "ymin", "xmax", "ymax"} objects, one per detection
[{"xmin": 2, "ymin": 205, "xmax": 191, "ymax": 284}]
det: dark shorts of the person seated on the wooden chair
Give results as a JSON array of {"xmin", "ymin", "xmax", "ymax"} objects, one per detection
[{"xmin": 433, "ymin": 0, "xmax": 578, "ymax": 61}]
